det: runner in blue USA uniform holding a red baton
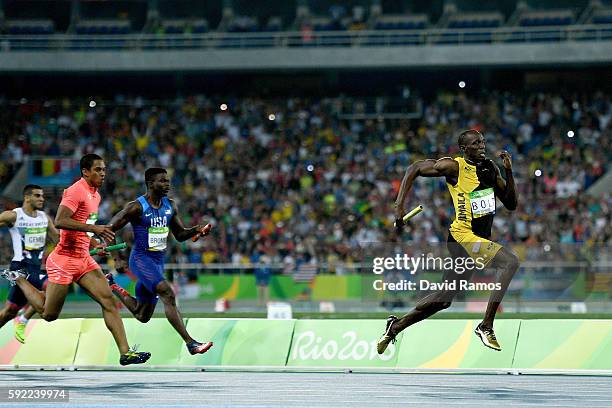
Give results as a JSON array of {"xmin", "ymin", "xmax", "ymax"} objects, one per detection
[{"xmin": 106, "ymin": 167, "xmax": 213, "ymax": 354}]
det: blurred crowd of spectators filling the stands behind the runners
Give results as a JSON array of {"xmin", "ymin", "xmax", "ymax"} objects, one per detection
[{"xmin": 0, "ymin": 92, "xmax": 612, "ymax": 263}]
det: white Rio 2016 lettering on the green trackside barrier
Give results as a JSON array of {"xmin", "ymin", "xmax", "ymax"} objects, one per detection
[{"xmin": 291, "ymin": 330, "xmax": 396, "ymax": 361}]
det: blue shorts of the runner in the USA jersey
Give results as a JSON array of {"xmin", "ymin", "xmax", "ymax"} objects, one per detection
[{"xmin": 129, "ymin": 251, "xmax": 166, "ymax": 304}]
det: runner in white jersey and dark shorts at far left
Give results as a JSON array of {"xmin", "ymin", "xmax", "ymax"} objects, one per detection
[{"xmin": 0, "ymin": 184, "xmax": 59, "ymax": 343}]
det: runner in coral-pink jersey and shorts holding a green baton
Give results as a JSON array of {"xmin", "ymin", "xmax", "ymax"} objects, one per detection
[{"xmin": 2, "ymin": 154, "xmax": 151, "ymax": 365}]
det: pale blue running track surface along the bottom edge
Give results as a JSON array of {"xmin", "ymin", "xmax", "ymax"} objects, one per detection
[{"xmin": 0, "ymin": 370, "xmax": 612, "ymax": 408}]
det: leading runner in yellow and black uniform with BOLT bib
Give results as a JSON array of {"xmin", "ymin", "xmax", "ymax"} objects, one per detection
[{"xmin": 378, "ymin": 130, "xmax": 519, "ymax": 354}]
